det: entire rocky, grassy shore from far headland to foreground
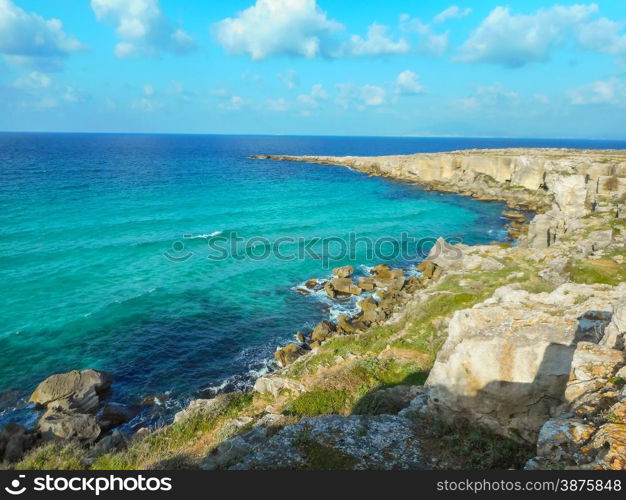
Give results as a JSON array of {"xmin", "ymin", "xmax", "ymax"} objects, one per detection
[{"xmin": 0, "ymin": 149, "xmax": 626, "ymax": 469}]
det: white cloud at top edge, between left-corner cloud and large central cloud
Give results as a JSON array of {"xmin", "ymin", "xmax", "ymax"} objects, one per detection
[{"xmin": 91, "ymin": 0, "xmax": 195, "ymax": 57}]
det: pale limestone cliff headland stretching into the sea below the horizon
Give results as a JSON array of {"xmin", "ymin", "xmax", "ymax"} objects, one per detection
[{"xmin": 256, "ymin": 149, "xmax": 626, "ymax": 215}]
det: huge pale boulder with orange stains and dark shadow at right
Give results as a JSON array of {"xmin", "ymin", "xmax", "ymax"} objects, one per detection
[{"xmin": 426, "ymin": 284, "xmax": 626, "ymax": 442}]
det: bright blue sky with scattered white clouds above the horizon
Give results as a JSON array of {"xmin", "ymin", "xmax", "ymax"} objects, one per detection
[{"xmin": 0, "ymin": 0, "xmax": 626, "ymax": 139}]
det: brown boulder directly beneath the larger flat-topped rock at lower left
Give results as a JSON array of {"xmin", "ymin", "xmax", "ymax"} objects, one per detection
[{"xmin": 39, "ymin": 409, "xmax": 101, "ymax": 442}]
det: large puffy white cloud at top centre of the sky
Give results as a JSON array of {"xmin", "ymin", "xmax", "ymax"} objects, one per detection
[{"xmin": 215, "ymin": 0, "xmax": 343, "ymax": 60}]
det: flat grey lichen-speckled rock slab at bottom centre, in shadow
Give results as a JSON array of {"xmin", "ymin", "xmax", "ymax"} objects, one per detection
[{"xmin": 230, "ymin": 415, "xmax": 426, "ymax": 470}]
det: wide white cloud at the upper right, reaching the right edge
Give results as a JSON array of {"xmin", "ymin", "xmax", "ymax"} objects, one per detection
[{"xmin": 457, "ymin": 4, "xmax": 626, "ymax": 67}]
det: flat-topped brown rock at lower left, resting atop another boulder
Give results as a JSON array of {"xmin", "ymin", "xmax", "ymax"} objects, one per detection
[{"xmin": 29, "ymin": 370, "xmax": 111, "ymax": 413}]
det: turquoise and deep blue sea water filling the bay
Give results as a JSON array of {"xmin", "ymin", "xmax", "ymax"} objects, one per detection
[{"xmin": 0, "ymin": 134, "xmax": 616, "ymax": 420}]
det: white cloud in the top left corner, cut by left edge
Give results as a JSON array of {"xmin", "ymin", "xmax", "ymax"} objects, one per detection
[{"xmin": 0, "ymin": 0, "xmax": 85, "ymax": 70}]
